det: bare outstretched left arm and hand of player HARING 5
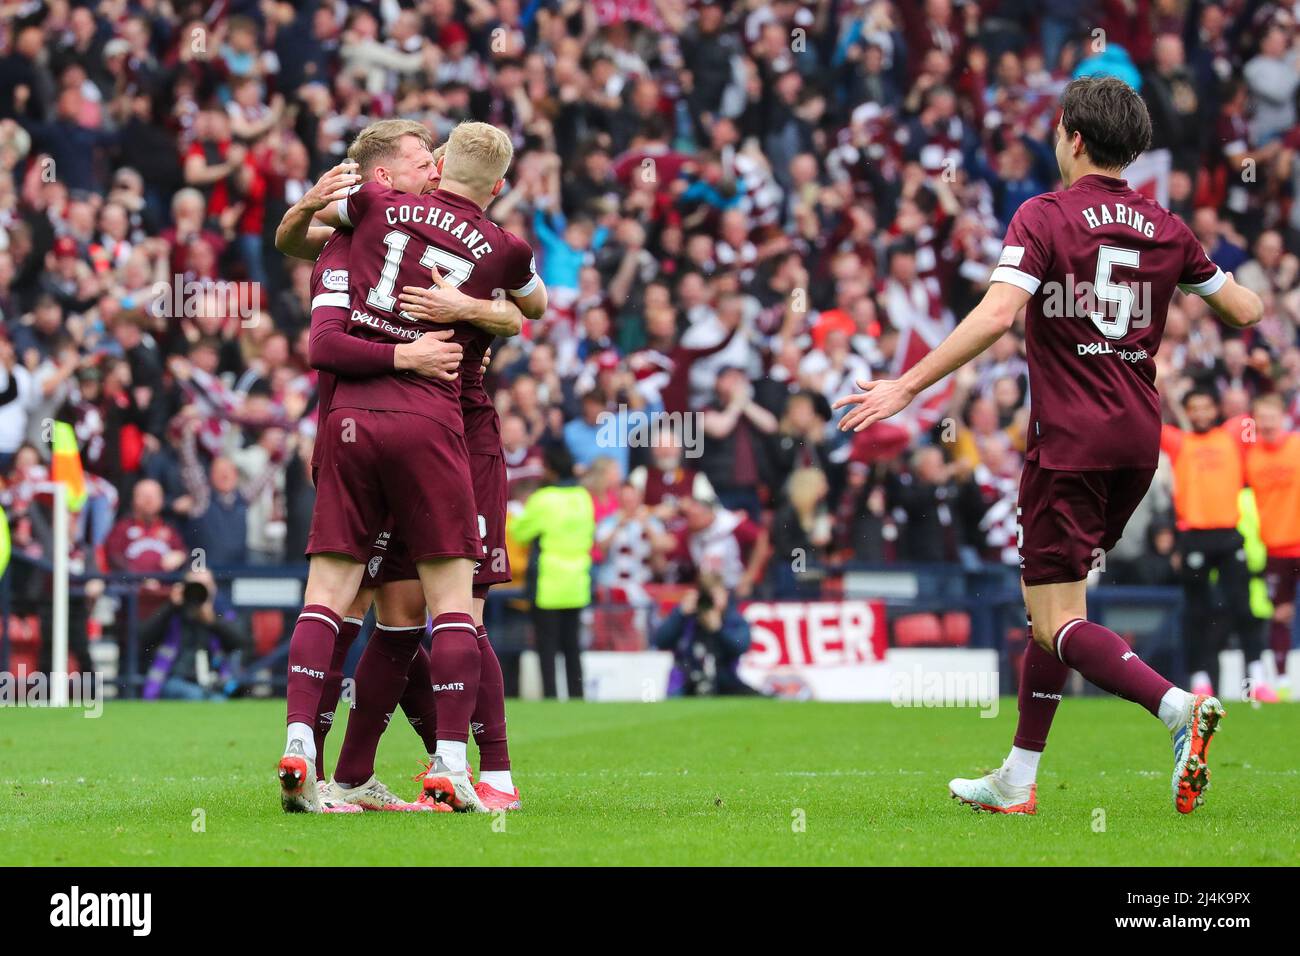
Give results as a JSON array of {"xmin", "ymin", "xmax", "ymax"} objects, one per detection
[{"xmin": 833, "ymin": 282, "xmax": 1030, "ymax": 432}]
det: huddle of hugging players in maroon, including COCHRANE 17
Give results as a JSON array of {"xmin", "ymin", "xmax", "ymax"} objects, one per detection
[{"xmin": 277, "ymin": 121, "xmax": 546, "ymax": 812}]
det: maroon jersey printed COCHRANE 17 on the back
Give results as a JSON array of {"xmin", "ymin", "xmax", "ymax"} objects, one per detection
[{"xmin": 334, "ymin": 182, "xmax": 538, "ymax": 434}]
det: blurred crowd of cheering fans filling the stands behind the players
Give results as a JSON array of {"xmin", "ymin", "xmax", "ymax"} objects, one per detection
[{"xmin": 0, "ymin": 0, "xmax": 1300, "ymax": 697}]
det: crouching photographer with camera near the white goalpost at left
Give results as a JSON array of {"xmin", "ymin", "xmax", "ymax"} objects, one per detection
[{"xmin": 140, "ymin": 571, "xmax": 248, "ymax": 700}]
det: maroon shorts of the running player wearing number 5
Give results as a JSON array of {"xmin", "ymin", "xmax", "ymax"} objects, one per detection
[{"xmin": 1017, "ymin": 462, "xmax": 1156, "ymax": 584}]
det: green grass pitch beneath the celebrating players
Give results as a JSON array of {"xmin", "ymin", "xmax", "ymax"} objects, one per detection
[{"xmin": 0, "ymin": 697, "xmax": 1300, "ymax": 866}]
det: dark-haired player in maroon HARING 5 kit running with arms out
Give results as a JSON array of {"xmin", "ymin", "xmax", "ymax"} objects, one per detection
[{"xmin": 836, "ymin": 77, "xmax": 1264, "ymax": 813}]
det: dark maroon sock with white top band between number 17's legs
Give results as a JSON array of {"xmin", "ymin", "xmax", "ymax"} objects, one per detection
[{"xmin": 334, "ymin": 626, "xmax": 424, "ymax": 787}]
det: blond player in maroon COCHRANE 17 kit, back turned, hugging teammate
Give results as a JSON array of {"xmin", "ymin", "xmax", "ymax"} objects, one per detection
[{"xmin": 308, "ymin": 117, "xmax": 546, "ymax": 810}]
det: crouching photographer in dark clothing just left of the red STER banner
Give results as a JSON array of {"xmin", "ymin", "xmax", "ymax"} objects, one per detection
[{"xmin": 653, "ymin": 574, "xmax": 758, "ymax": 697}]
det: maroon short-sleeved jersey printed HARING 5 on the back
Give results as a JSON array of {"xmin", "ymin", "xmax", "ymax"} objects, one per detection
[{"xmin": 992, "ymin": 176, "xmax": 1225, "ymax": 471}]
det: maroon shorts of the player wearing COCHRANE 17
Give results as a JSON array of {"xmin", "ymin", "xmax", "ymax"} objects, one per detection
[{"xmin": 307, "ymin": 407, "xmax": 482, "ymax": 562}]
